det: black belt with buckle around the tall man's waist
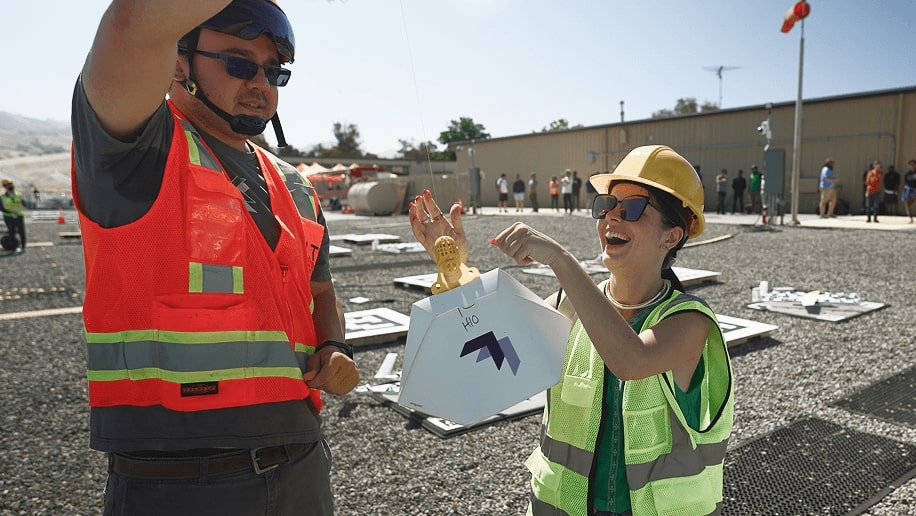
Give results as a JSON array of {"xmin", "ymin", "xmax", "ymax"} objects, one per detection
[{"xmin": 111, "ymin": 443, "xmax": 315, "ymax": 480}]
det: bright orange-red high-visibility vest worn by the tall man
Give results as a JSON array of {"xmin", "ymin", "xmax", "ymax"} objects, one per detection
[{"xmin": 74, "ymin": 102, "xmax": 324, "ymax": 411}]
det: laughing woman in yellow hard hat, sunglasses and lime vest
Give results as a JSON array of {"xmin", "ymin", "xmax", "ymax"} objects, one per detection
[{"xmin": 409, "ymin": 145, "xmax": 734, "ymax": 515}]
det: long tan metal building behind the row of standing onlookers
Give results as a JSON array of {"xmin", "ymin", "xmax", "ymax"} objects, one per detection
[{"xmin": 452, "ymin": 86, "xmax": 916, "ymax": 213}]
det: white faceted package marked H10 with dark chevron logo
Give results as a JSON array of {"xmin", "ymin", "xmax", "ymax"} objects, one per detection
[{"xmin": 398, "ymin": 269, "xmax": 571, "ymax": 425}]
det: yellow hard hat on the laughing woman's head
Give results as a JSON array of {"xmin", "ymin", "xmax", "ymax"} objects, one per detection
[{"xmin": 589, "ymin": 145, "xmax": 706, "ymax": 238}]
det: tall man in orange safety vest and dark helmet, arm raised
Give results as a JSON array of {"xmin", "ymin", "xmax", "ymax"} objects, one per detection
[{"xmin": 71, "ymin": 0, "xmax": 359, "ymax": 515}]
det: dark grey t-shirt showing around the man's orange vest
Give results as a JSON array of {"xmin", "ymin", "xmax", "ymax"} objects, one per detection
[{"xmin": 71, "ymin": 80, "xmax": 331, "ymax": 452}]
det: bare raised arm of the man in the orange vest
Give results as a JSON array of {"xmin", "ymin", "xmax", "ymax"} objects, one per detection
[{"xmin": 81, "ymin": 0, "xmax": 229, "ymax": 140}]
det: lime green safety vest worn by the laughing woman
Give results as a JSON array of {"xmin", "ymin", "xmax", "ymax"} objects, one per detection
[{"xmin": 525, "ymin": 290, "xmax": 734, "ymax": 516}]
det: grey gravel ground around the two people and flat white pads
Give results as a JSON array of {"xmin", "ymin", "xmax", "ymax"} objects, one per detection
[{"xmin": 0, "ymin": 214, "xmax": 916, "ymax": 516}]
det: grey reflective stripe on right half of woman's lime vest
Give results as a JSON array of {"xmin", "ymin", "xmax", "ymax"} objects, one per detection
[{"xmin": 627, "ymin": 400, "xmax": 728, "ymax": 491}]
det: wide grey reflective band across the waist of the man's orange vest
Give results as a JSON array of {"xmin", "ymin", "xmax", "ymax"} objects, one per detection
[{"xmin": 88, "ymin": 341, "xmax": 301, "ymax": 372}]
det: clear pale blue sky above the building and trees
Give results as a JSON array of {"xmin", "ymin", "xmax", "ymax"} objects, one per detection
[{"xmin": 0, "ymin": 0, "xmax": 916, "ymax": 155}]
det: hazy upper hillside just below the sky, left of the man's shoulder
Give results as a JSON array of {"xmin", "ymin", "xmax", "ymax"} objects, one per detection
[{"xmin": 0, "ymin": 111, "xmax": 71, "ymax": 159}]
